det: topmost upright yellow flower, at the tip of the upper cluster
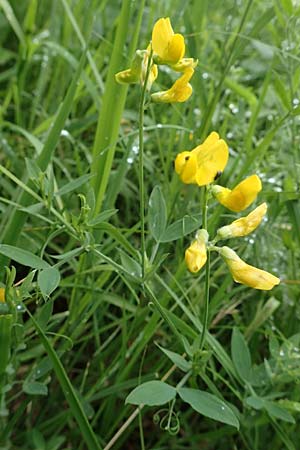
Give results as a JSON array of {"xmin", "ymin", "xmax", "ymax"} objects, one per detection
[{"xmin": 152, "ymin": 17, "xmax": 185, "ymax": 64}]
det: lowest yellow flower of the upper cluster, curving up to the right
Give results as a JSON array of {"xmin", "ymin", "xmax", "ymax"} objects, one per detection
[{"xmin": 151, "ymin": 67, "xmax": 194, "ymax": 103}]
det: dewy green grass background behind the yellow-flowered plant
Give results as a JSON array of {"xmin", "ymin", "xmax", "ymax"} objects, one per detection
[{"xmin": 0, "ymin": 0, "xmax": 300, "ymax": 450}]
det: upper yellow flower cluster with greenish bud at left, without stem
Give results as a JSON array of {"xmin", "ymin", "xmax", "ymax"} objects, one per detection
[{"xmin": 115, "ymin": 17, "xmax": 197, "ymax": 103}]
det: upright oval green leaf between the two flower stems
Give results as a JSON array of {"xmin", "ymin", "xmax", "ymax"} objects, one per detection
[{"xmin": 148, "ymin": 186, "xmax": 167, "ymax": 242}]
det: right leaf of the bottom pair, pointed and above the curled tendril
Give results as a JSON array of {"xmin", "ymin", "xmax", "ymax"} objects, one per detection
[{"xmin": 178, "ymin": 388, "xmax": 239, "ymax": 429}]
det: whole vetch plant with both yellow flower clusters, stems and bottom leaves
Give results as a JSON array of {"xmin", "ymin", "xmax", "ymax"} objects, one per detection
[{"xmin": 116, "ymin": 14, "xmax": 279, "ymax": 433}]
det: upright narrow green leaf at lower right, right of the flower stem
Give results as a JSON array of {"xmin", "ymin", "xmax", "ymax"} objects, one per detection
[{"xmin": 231, "ymin": 327, "xmax": 252, "ymax": 381}]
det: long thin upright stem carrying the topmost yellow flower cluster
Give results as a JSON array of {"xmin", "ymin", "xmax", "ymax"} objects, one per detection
[{"xmin": 139, "ymin": 49, "xmax": 152, "ymax": 279}]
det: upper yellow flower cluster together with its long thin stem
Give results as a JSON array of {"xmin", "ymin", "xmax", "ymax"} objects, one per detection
[{"xmin": 115, "ymin": 17, "xmax": 197, "ymax": 279}]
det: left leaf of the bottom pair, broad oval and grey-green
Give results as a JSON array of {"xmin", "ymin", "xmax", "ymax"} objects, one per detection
[{"xmin": 125, "ymin": 381, "xmax": 176, "ymax": 406}]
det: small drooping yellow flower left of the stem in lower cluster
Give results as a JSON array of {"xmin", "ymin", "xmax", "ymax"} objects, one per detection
[{"xmin": 185, "ymin": 230, "xmax": 208, "ymax": 273}]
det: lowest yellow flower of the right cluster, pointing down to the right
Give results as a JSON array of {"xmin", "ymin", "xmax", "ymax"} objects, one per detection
[{"xmin": 220, "ymin": 247, "xmax": 280, "ymax": 291}]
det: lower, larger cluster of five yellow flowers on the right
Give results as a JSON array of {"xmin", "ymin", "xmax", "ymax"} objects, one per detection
[{"xmin": 175, "ymin": 132, "xmax": 280, "ymax": 290}]
